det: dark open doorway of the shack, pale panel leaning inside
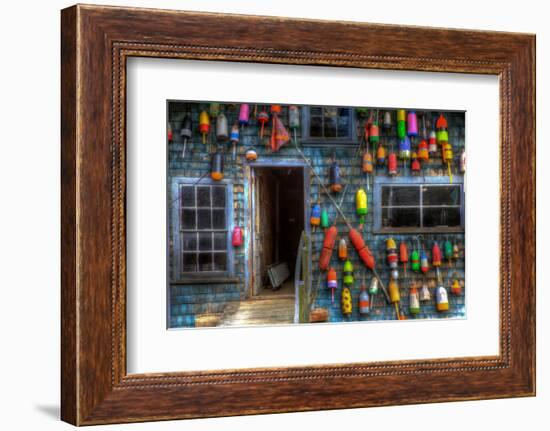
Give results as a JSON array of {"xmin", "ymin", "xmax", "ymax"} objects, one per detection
[{"xmin": 251, "ymin": 166, "xmax": 305, "ymax": 298}]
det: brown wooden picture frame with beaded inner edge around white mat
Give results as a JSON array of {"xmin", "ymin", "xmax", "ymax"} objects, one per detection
[{"xmin": 61, "ymin": 5, "xmax": 535, "ymax": 425}]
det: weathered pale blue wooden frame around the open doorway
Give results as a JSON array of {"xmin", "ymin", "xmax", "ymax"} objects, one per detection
[{"xmin": 244, "ymin": 158, "xmax": 311, "ymax": 304}]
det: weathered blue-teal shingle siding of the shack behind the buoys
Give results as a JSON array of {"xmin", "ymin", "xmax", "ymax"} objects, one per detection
[{"xmin": 169, "ymin": 102, "xmax": 466, "ymax": 328}]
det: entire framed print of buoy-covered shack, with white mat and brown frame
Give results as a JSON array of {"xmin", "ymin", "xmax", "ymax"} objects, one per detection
[{"xmin": 62, "ymin": 5, "xmax": 535, "ymax": 425}]
